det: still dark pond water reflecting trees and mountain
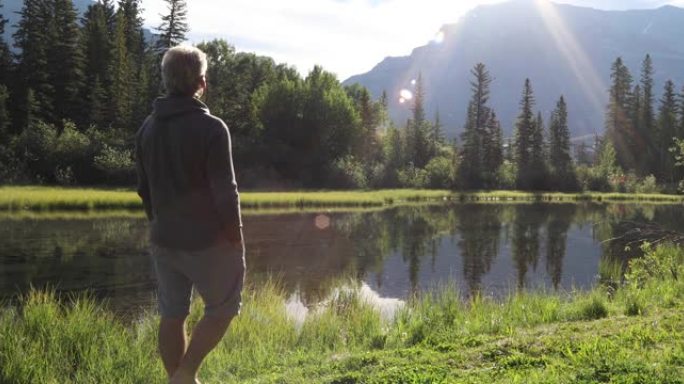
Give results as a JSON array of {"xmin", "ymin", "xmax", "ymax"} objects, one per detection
[{"xmin": 0, "ymin": 204, "xmax": 684, "ymax": 313}]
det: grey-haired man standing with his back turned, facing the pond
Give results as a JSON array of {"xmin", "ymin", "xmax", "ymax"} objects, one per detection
[{"xmin": 136, "ymin": 46, "xmax": 245, "ymax": 384}]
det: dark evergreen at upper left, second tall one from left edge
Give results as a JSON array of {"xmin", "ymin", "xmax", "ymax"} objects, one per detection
[{"xmin": 48, "ymin": 0, "xmax": 87, "ymax": 122}]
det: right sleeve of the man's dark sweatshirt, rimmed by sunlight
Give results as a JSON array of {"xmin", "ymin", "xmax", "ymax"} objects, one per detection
[{"xmin": 207, "ymin": 123, "xmax": 242, "ymax": 242}]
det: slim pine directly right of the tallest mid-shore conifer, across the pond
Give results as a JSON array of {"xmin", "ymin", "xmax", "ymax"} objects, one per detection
[{"xmin": 514, "ymin": 79, "xmax": 536, "ymax": 189}]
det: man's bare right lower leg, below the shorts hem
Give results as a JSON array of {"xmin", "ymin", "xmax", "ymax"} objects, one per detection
[{"xmin": 171, "ymin": 315, "xmax": 233, "ymax": 384}]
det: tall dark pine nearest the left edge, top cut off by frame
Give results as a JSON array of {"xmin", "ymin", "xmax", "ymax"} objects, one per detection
[{"xmin": 13, "ymin": 0, "xmax": 55, "ymax": 126}]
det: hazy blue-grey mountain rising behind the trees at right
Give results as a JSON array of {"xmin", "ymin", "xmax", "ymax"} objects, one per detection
[{"xmin": 344, "ymin": 0, "xmax": 684, "ymax": 137}]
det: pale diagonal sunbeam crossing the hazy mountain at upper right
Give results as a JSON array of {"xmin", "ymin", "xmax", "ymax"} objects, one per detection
[{"xmin": 535, "ymin": 0, "xmax": 608, "ymax": 121}]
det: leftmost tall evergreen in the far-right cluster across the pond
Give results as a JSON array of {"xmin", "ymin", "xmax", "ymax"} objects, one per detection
[{"xmin": 606, "ymin": 57, "xmax": 636, "ymax": 169}]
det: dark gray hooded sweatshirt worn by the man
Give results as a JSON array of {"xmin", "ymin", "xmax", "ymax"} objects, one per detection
[{"xmin": 136, "ymin": 97, "xmax": 242, "ymax": 250}]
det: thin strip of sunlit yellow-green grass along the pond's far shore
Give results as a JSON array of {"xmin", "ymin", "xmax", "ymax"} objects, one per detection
[{"xmin": 0, "ymin": 187, "xmax": 684, "ymax": 211}]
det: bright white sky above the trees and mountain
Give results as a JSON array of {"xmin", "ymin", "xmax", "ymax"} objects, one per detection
[{"xmin": 143, "ymin": 0, "xmax": 684, "ymax": 80}]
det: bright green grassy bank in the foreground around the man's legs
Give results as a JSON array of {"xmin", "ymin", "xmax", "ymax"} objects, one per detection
[{"xmin": 0, "ymin": 244, "xmax": 684, "ymax": 384}]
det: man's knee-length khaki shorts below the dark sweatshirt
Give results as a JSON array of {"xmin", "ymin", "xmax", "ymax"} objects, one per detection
[{"xmin": 151, "ymin": 243, "xmax": 245, "ymax": 318}]
